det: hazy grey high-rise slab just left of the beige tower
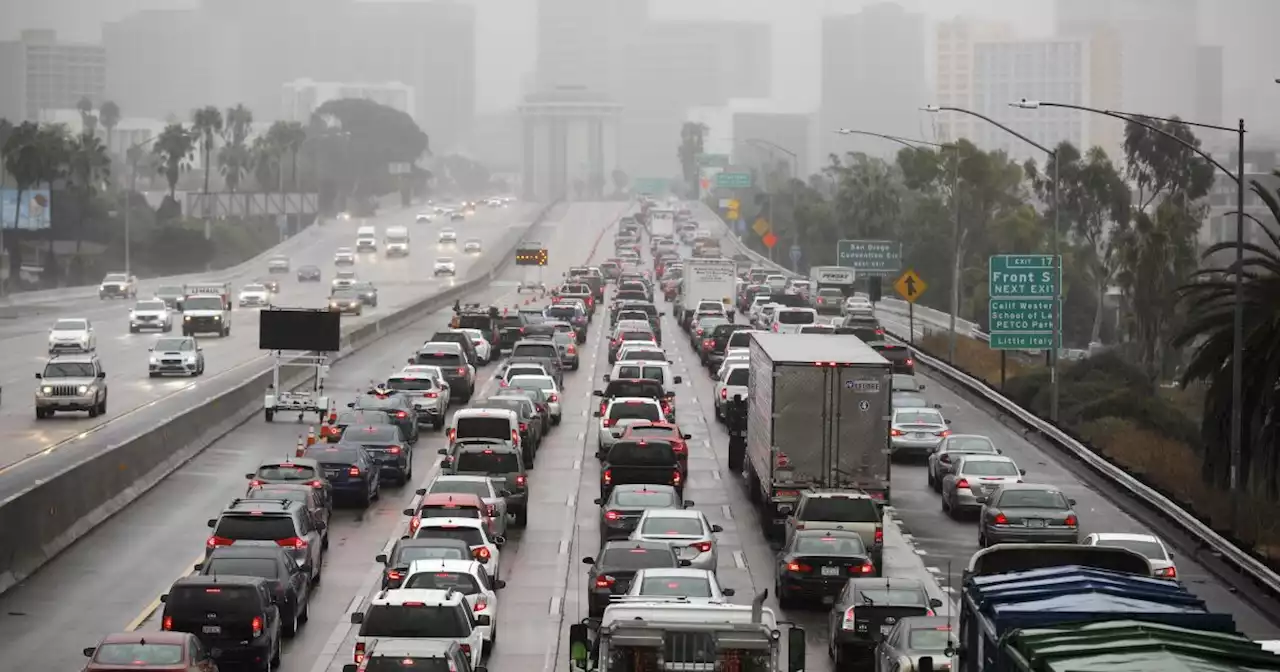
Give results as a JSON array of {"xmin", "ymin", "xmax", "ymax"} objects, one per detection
[{"xmin": 818, "ymin": 3, "xmax": 929, "ymax": 161}]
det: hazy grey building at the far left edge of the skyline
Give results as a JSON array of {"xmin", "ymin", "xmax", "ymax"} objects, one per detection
[{"xmin": 0, "ymin": 31, "xmax": 106, "ymax": 122}]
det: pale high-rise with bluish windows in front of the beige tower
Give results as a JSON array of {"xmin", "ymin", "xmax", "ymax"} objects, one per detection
[{"xmin": 972, "ymin": 38, "xmax": 1095, "ymax": 164}]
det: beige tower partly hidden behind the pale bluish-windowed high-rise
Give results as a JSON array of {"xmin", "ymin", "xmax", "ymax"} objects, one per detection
[{"xmin": 933, "ymin": 18, "xmax": 1014, "ymax": 142}]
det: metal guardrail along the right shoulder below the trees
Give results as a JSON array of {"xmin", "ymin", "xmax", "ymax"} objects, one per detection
[{"xmin": 700, "ymin": 204, "xmax": 1280, "ymax": 599}]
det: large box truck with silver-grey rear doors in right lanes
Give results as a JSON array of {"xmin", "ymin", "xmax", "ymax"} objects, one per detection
[{"xmin": 730, "ymin": 333, "xmax": 892, "ymax": 536}]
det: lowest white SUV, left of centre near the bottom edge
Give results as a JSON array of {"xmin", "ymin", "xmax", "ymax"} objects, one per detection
[{"xmin": 351, "ymin": 589, "xmax": 490, "ymax": 672}]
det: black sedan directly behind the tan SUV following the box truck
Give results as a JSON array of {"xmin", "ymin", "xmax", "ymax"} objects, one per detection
[{"xmin": 773, "ymin": 529, "xmax": 879, "ymax": 609}]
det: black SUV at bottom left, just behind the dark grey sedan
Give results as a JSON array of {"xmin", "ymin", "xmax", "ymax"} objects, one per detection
[{"xmin": 160, "ymin": 575, "xmax": 280, "ymax": 671}]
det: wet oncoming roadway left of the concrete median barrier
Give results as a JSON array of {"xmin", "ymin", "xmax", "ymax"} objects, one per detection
[{"xmin": 0, "ymin": 204, "xmax": 538, "ymax": 499}]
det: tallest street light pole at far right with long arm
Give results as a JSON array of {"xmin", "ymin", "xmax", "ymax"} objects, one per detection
[{"xmin": 1009, "ymin": 99, "xmax": 1244, "ymax": 483}]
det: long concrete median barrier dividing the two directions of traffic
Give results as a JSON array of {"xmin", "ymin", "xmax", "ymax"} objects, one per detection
[{"xmin": 0, "ymin": 202, "xmax": 559, "ymax": 594}]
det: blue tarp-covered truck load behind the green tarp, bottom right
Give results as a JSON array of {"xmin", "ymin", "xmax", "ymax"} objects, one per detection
[{"xmin": 960, "ymin": 566, "xmax": 1235, "ymax": 672}]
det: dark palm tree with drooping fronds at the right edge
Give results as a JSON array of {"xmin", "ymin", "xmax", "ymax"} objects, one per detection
[{"xmin": 1171, "ymin": 182, "xmax": 1280, "ymax": 488}]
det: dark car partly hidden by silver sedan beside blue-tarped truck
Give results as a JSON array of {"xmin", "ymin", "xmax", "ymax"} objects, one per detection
[{"xmin": 827, "ymin": 577, "xmax": 942, "ymax": 669}]
